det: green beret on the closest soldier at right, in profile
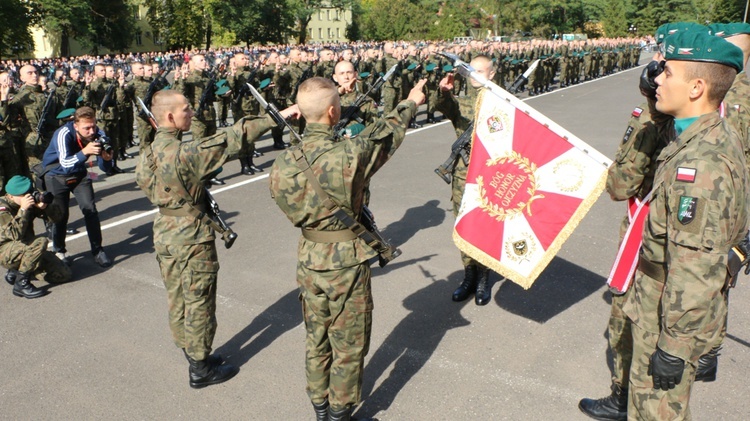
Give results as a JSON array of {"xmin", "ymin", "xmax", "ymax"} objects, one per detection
[{"xmin": 664, "ymin": 31, "xmax": 744, "ymax": 72}]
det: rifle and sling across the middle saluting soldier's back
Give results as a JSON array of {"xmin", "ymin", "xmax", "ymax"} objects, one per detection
[{"xmin": 248, "ymin": 82, "xmax": 401, "ymax": 267}]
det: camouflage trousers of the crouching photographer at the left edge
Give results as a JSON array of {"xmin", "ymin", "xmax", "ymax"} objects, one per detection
[{"xmin": 0, "ymin": 237, "xmax": 73, "ymax": 284}]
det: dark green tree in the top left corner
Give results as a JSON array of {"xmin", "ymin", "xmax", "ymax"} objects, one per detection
[{"xmin": 0, "ymin": 0, "xmax": 35, "ymax": 58}]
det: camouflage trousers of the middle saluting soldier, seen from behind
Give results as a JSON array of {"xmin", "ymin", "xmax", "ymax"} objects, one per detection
[{"xmin": 297, "ymin": 262, "xmax": 373, "ymax": 410}]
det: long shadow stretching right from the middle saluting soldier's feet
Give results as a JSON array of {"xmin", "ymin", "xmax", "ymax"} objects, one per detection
[{"xmin": 356, "ymin": 268, "xmax": 470, "ymax": 418}]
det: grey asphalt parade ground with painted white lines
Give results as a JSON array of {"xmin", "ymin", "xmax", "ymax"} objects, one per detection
[{"xmin": 0, "ymin": 63, "xmax": 750, "ymax": 421}]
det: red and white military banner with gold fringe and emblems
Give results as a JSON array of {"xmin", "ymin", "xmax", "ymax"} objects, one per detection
[{"xmin": 453, "ymin": 83, "xmax": 611, "ymax": 289}]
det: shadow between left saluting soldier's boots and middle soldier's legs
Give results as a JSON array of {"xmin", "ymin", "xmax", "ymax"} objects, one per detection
[{"xmin": 216, "ymin": 288, "xmax": 302, "ymax": 367}]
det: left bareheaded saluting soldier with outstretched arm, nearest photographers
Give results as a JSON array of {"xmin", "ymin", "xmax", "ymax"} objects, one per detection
[{"xmin": 136, "ymin": 90, "xmax": 296, "ymax": 389}]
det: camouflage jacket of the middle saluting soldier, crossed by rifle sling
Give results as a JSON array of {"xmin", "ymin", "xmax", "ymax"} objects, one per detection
[{"xmin": 270, "ymin": 101, "xmax": 416, "ymax": 270}]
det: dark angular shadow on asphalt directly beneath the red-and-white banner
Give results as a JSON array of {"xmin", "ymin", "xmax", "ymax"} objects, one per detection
[{"xmin": 494, "ymin": 257, "xmax": 607, "ymax": 323}]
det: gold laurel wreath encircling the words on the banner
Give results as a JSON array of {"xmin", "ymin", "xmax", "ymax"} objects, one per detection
[{"xmin": 476, "ymin": 151, "xmax": 544, "ymax": 221}]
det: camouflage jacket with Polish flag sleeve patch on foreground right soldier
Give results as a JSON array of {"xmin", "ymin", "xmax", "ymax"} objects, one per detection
[{"xmin": 623, "ymin": 112, "xmax": 748, "ymax": 363}]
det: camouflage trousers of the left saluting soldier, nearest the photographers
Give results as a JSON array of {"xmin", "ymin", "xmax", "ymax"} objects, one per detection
[{"xmin": 154, "ymin": 241, "xmax": 219, "ymax": 361}]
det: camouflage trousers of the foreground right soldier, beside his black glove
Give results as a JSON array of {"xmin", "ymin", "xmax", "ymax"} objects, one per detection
[{"xmin": 628, "ymin": 323, "xmax": 695, "ymax": 421}]
